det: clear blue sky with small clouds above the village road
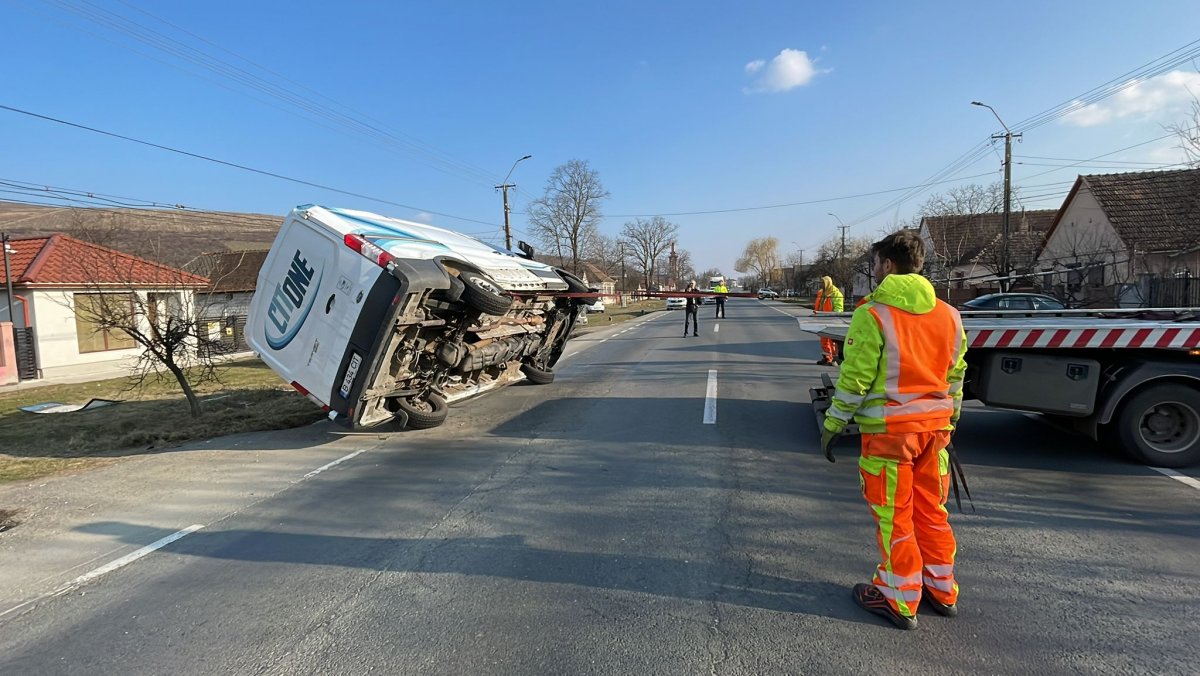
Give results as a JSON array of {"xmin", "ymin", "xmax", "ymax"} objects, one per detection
[{"xmin": 0, "ymin": 0, "xmax": 1200, "ymax": 273}]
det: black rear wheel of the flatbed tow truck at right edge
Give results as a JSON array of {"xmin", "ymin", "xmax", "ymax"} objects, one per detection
[{"xmin": 1117, "ymin": 383, "xmax": 1200, "ymax": 467}]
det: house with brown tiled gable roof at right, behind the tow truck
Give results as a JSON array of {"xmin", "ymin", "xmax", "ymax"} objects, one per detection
[{"xmin": 1037, "ymin": 169, "xmax": 1200, "ymax": 306}]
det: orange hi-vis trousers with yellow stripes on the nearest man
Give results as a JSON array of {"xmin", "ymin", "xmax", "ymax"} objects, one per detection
[{"xmin": 858, "ymin": 430, "xmax": 959, "ymax": 617}]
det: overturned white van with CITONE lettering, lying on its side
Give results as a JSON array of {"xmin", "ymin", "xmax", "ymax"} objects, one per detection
[{"xmin": 246, "ymin": 205, "xmax": 590, "ymax": 429}]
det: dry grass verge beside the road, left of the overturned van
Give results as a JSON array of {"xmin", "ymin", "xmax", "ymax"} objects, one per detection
[{"xmin": 0, "ymin": 360, "xmax": 323, "ymax": 483}]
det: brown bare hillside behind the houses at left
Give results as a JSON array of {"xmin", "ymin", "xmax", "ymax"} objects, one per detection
[{"xmin": 0, "ymin": 202, "xmax": 283, "ymax": 265}]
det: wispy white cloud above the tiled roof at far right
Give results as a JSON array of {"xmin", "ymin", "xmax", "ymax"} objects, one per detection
[{"xmin": 1062, "ymin": 71, "xmax": 1200, "ymax": 127}]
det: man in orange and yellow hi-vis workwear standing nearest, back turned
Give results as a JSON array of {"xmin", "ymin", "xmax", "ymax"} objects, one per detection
[{"xmin": 821, "ymin": 229, "xmax": 967, "ymax": 629}]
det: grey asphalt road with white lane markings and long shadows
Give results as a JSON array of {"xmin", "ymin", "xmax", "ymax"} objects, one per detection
[{"xmin": 0, "ymin": 300, "xmax": 1200, "ymax": 675}]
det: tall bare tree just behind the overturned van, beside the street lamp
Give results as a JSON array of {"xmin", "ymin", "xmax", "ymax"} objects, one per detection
[{"xmin": 529, "ymin": 160, "xmax": 608, "ymax": 274}]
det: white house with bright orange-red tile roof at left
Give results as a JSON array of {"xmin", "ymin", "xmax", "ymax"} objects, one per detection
[{"xmin": 0, "ymin": 234, "xmax": 209, "ymax": 378}]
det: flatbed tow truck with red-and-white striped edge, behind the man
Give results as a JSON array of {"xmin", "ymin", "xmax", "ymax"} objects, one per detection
[{"xmin": 802, "ymin": 309, "xmax": 1200, "ymax": 467}]
